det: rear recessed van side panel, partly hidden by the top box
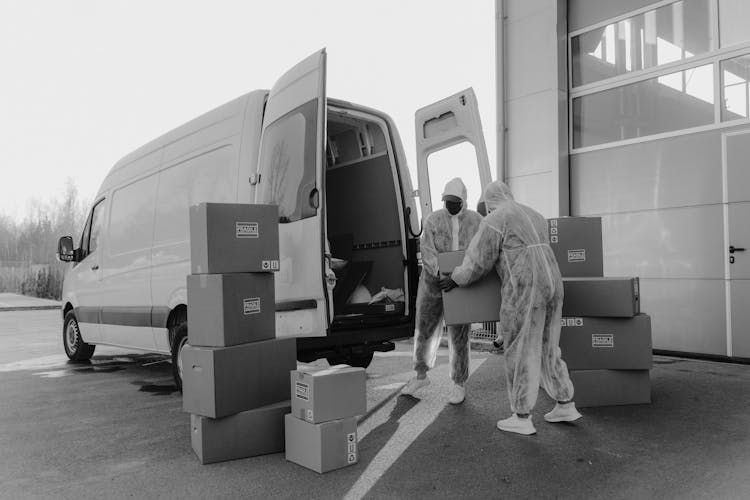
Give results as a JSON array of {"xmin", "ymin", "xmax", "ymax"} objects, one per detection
[{"xmin": 154, "ymin": 147, "xmax": 237, "ymax": 245}]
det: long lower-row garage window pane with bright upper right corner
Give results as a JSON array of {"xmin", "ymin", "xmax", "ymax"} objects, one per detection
[{"xmin": 573, "ymin": 64, "xmax": 714, "ymax": 148}]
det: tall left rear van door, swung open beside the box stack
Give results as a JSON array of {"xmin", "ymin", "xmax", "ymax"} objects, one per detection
[{"xmin": 255, "ymin": 49, "xmax": 330, "ymax": 336}]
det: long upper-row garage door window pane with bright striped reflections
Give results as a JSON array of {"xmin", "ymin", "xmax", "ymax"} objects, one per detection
[{"xmin": 571, "ymin": 0, "xmax": 713, "ymax": 87}]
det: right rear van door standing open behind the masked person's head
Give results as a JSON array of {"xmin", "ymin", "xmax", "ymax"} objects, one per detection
[{"xmin": 415, "ymin": 87, "xmax": 492, "ymax": 217}]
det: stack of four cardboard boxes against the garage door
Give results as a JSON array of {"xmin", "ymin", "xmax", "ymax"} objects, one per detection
[{"xmin": 549, "ymin": 217, "xmax": 652, "ymax": 407}]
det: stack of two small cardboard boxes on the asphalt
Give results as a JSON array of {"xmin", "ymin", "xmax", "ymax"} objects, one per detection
[{"xmin": 284, "ymin": 365, "xmax": 367, "ymax": 473}]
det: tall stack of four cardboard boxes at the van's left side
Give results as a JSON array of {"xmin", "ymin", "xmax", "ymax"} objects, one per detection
[{"xmin": 182, "ymin": 203, "xmax": 297, "ymax": 464}]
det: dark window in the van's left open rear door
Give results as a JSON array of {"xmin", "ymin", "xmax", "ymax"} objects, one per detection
[{"xmin": 257, "ymin": 99, "xmax": 318, "ymax": 223}]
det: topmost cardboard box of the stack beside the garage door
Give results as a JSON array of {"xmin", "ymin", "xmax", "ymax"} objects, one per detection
[{"xmin": 547, "ymin": 217, "xmax": 604, "ymax": 277}]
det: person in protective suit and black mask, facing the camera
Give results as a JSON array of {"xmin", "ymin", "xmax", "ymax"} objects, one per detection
[{"xmin": 401, "ymin": 177, "xmax": 482, "ymax": 404}]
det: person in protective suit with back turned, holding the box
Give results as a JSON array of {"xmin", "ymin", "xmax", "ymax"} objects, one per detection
[{"xmin": 440, "ymin": 181, "xmax": 581, "ymax": 435}]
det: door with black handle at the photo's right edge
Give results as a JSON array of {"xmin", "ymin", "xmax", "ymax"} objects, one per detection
[{"xmin": 723, "ymin": 131, "xmax": 750, "ymax": 358}]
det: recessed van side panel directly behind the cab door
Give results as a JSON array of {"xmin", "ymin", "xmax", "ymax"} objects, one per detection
[{"xmin": 106, "ymin": 175, "xmax": 156, "ymax": 255}]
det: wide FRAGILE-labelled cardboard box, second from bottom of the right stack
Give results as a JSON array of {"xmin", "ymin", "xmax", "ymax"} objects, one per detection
[{"xmin": 560, "ymin": 314, "xmax": 653, "ymax": 370}]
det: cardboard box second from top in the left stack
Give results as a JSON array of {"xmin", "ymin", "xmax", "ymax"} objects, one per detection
[{"xmin": 187, "ymin": 273, "xmax": 276, "ymax": 347}]
